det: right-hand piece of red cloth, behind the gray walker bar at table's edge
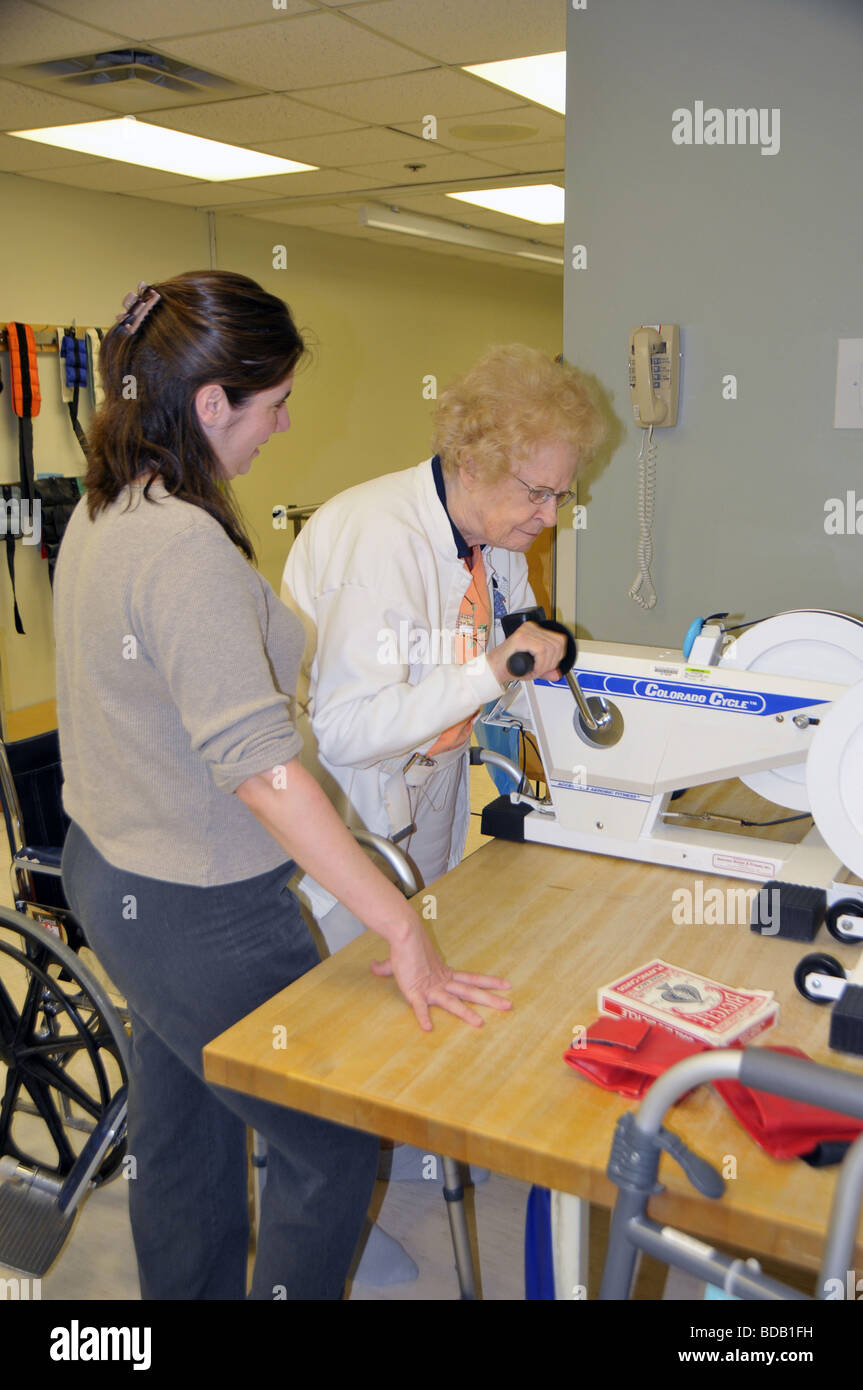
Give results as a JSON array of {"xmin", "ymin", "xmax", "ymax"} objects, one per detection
[{"xmin": 713, "ymin": 1047, "xmax": 863, "ymax": 1158}]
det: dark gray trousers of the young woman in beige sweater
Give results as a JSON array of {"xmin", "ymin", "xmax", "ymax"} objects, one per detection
[{"xmin": 63, "ymin": 823, "xmax": 378, "ymax": 1300}]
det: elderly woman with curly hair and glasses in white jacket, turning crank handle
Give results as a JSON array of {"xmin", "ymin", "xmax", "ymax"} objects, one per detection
[{"xmin": 282, "ymin": 345, "xmax": 605, "ymax": 951}]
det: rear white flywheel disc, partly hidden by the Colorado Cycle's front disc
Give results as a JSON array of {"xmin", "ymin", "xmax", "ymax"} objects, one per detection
[{"xmin": 720, "ymin": 609, "xmax": 863, "ymax": 811}]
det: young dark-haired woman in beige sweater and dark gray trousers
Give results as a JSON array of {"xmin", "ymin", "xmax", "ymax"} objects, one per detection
[{"xmin": 54, "ymin": 271, "xmax": 509, "ymax": 1300}]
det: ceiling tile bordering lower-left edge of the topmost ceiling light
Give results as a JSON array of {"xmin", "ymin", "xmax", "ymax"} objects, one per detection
[{"xmin": 295, "ymin": 68, "xmax": 525, "ymax": 124}]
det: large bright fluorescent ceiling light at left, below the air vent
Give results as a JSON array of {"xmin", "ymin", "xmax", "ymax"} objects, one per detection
[{"xmin": 8, "ymin": 115, "xmax": 317, "ymax": 183}]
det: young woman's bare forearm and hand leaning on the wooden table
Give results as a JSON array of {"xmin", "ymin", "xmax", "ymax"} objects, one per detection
[{"xmin": 236, "ymin": 761, "xmax": 511, "ymax": 1031}]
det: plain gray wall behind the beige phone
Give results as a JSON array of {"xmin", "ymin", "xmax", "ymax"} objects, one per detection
[{"xmin": 564, "ymin": 0, "xmax": 863, "ymax": 646}]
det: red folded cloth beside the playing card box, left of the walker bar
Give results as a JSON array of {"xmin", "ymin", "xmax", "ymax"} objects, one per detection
[{"xmin": 563, "ymin": 1015, "xmax": 709, "ymax": 1099}]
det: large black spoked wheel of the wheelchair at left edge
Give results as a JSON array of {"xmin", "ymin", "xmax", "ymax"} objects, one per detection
[{"xmin": 0, "ymin": 908, "xmax": 129, "ymax": 1183}]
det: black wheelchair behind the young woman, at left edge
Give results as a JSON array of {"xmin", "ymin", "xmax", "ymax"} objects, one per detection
[{"xmin": 0, "ymin": 731, "xmax": 129, "ymax": 1276}]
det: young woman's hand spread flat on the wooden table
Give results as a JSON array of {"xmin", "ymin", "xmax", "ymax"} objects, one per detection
[{"xmin": 371, "ymin": 920, "xmax": 513, "ymax": 1033}]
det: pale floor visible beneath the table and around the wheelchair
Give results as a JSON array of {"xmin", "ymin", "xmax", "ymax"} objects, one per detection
[{"xmin": 0, "ymin": 767, "xmax": 812, "ymax": 1301}]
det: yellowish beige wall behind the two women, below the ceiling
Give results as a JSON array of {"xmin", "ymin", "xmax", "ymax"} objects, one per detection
[{"xmin": 0, "ymin": 175, "xmax": 561, "ymax": 710}]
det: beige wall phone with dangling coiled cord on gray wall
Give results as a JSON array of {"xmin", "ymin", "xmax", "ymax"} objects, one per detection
[{"xmin": 630, "ymin": 324, "xmax": 680, "ymax": 609}]
